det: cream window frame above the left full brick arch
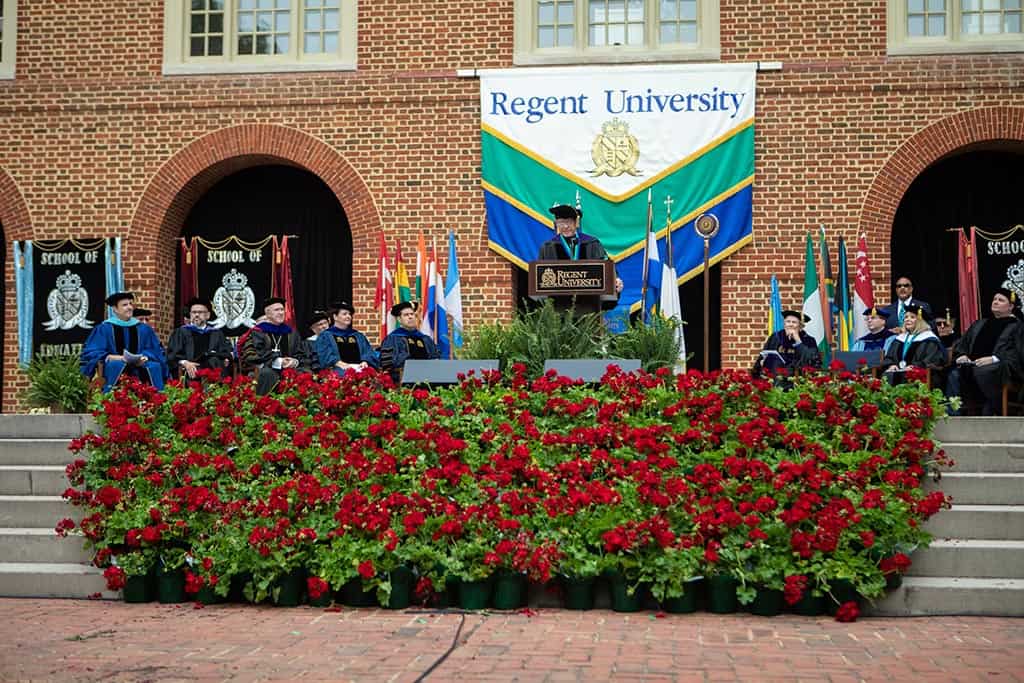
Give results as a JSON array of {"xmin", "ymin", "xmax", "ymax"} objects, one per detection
[{"xmin": 163, "ymin": 0, "xmax": 358, "ymax": 76}]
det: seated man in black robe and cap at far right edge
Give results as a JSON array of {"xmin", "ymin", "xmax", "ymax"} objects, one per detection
[{"xmin": 947, "ymin": 289, "xmax": 1022, "ymax": 415}]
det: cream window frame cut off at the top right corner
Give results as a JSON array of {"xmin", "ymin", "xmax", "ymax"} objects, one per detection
[{"xmin": 887, "ymin": 0, "xmax": 1024, "ymax": 55}]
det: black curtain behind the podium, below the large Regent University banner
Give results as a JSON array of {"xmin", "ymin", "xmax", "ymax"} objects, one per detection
[{"xmin": 514, "ymin": 265, "xmax": 720, "ymax": 370}]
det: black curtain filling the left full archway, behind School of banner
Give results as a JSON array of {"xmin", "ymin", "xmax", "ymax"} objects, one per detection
[{"xmin": 178, "ymin": 166, "xmax": 352, "ymax": 336}]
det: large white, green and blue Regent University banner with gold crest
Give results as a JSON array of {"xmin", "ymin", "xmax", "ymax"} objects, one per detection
[{"xmin": 480, "ymin": 63, "xmax": 756, "ymax": 307}]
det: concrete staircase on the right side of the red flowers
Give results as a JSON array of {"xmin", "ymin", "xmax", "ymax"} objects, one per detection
[{"xmin": 868, "ymin": 418, "xmax": 1024, "ymax": 616}]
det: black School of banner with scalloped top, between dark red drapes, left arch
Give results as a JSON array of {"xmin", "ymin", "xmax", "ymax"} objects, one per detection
[{"xmin": 196, "ymin": 236, "xmax": 274, "ymax": 339}]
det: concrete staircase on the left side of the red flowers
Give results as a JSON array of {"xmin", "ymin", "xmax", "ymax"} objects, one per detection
[{"xmin": 0, "ymin": 415, "xmax": 117, "ymax": 598}]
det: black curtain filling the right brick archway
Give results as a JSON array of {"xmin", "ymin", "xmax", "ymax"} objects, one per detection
[{"xmin": 886, "ymin": 151, "xmax": 1024, "ymax": 321}]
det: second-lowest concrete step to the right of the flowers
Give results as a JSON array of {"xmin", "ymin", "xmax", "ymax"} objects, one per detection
[{"xmin": 909, "ymin": 539, "xmax": 1024, "ymax": 580}]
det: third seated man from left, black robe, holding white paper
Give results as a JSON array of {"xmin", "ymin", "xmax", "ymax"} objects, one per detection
[{"xmin": 240, "ymin": 297, "xmax": 311, "ymax": 396}]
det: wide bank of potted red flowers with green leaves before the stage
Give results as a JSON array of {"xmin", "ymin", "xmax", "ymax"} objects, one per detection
[{"xmin": 58, "ymin": 368, "xmax": 947, "ymax": 617}]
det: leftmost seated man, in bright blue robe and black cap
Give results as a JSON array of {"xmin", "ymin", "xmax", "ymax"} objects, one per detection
[{"xmin": 79, "ymin": 292, "xmax": 167, "ymax": 392}]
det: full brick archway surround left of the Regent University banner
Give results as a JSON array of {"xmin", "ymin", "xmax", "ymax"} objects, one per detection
[{"xmin": 124, "ymin": 124, "xmax": 381, "ymax": 334}]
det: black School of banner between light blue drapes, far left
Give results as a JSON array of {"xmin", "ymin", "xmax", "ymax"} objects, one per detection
[{"xmin": 32, "ymin": 238, "xmax": 108, "ymax": 357}]
